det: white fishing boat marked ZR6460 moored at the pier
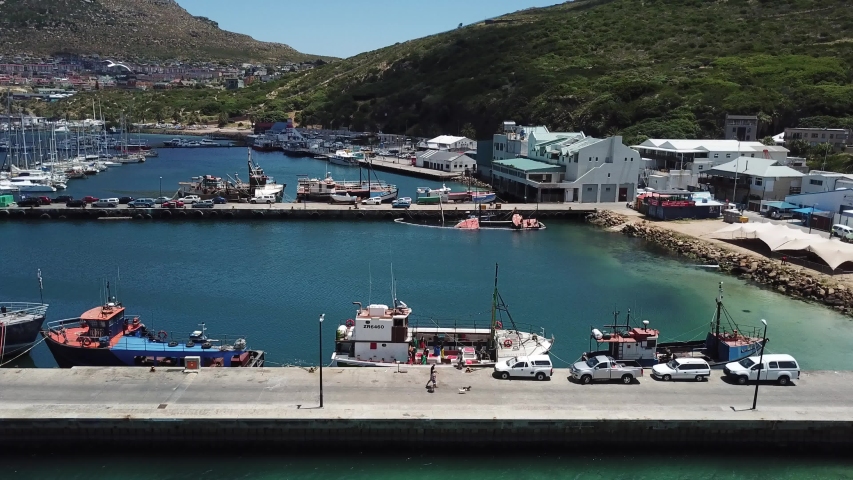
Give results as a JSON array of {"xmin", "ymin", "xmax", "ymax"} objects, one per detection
[{"xmin": 332, "ymin": 265, "xmax": 554, "ymax": 367}]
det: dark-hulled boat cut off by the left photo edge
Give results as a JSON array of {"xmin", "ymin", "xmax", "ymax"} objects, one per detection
[{"xmin": 0, "ymin": 302, "xmax": 48, "ymax": 358}]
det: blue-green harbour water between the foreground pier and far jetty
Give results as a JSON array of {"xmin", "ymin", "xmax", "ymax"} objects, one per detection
[{"xmin": 0, "ymin": 219, "xmax": 853, "ymax": 369}]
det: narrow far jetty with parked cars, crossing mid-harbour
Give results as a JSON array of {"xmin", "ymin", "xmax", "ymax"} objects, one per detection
[{"xmin": 0, "ymin": 202, "xmax": 604, "ymax": 223}]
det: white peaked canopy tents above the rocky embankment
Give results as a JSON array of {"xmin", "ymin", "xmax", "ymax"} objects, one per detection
[{"xmin": 713, "ymin": 223, "xmax": 853, "ymax": 270}]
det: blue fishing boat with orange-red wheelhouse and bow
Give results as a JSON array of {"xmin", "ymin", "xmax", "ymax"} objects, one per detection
[{"xmin": 41, "ymin": 287, "xmax": 264, "ymax": 368}]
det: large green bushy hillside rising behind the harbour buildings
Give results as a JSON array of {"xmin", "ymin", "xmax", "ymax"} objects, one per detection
[{"xmin": 31, "ymin": 0, "xmax": 853, "ymax": 143}]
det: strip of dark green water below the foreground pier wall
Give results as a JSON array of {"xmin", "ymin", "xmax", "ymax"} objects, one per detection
[{"xmin": 0, "ymin": 454, "xmax": 853, "ymax": 480}]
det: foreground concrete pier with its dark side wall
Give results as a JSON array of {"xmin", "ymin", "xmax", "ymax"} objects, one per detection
[{"xmin": 0, "ymin": 367, "xmax": 853, "ymax": 453}]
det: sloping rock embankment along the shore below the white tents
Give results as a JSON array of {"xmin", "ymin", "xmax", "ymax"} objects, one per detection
[{"xmin": 621, "ymin": 221, "xmax": 853, "ymax": 316}]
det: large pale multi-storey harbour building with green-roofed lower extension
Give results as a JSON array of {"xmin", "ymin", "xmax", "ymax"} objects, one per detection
[{"xmin": 492, "ymin": 136, "xmax": 640, "ymax": 203}]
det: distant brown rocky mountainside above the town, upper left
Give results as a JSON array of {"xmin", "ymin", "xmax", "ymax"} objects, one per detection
[{"xmin": 0, "ymin": 0, "xmax": 320, "ymax": 63}]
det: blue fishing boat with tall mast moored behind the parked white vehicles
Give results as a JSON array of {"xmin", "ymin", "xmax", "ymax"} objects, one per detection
[{"xmin": 582, "ymin": 282, "xmax": 763, "ymax": 367}]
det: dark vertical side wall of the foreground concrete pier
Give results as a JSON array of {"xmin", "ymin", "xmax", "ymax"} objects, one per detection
[{"xmin": 0, "ymin": 418, "xmax": 853, "ymax": 453}]
